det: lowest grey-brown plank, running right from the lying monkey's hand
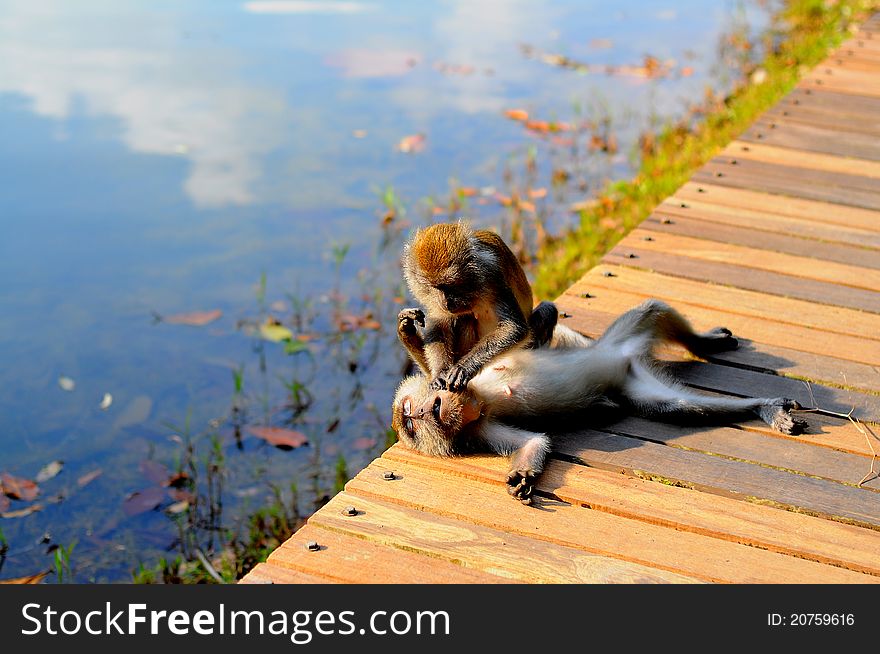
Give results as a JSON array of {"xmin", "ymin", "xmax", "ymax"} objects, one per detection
[{"xmin": 554, "ymin": 429, "xmax": 880, "ymax": 529}]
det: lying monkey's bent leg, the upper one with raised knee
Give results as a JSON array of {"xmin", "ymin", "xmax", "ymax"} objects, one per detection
[{"xmin": 600, "ymin": 299, "xmax": 738, "ymax": 356}]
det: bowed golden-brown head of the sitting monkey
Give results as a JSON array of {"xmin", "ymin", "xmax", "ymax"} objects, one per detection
[{"xmin": 403, "ymin": 222, "xmax": 488, "ymax": 315}]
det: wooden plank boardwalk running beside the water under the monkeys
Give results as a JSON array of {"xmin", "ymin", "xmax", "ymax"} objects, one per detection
[{"xmin": 243, "ymin": 16, "xmax": 880, "ymax": 583}]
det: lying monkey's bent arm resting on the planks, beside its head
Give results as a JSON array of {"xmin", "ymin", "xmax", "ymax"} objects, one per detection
[{"xmin": 480, "ymin": 420, "xmax": 550, "ymax": 504}]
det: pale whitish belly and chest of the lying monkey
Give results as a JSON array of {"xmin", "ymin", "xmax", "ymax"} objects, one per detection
[{"xmin": 469, "ymin": 347, "xmax": 630, "ymax": 416}]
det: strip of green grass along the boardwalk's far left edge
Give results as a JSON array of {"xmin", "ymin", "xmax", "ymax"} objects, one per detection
[{"xmin": 533, "ymin": 0, "xmax": 880, "ymax": 298}]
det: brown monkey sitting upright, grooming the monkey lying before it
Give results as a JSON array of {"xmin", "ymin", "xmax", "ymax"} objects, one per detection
[{"xmin": 398, "ymin": 222, "xmax": 557, "ymax": 391}]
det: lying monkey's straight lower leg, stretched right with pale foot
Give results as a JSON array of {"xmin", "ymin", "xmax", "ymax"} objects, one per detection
[{"xmin": 624, "ymin": 362, "xmax": 806, "ymax": 434}]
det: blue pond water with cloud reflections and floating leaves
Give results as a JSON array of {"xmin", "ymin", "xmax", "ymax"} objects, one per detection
[{"xmin": 0, "ymin": 0, "xmax": 768, "ymax": 581}]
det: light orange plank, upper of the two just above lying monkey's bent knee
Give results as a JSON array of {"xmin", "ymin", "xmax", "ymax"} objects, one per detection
[{"xmin": 575, "ymin": 262, "xmax": 880, "ymax": 344}]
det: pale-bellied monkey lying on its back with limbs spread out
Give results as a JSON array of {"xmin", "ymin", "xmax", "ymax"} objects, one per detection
[{"xmin": 392, "ymin": 300, "xmax": 805, "ymax": 504}]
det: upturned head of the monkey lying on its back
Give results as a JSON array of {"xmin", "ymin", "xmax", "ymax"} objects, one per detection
[{"xmin": 391, "ymin": 375, "xmax": 481, "ymax": 456}]
